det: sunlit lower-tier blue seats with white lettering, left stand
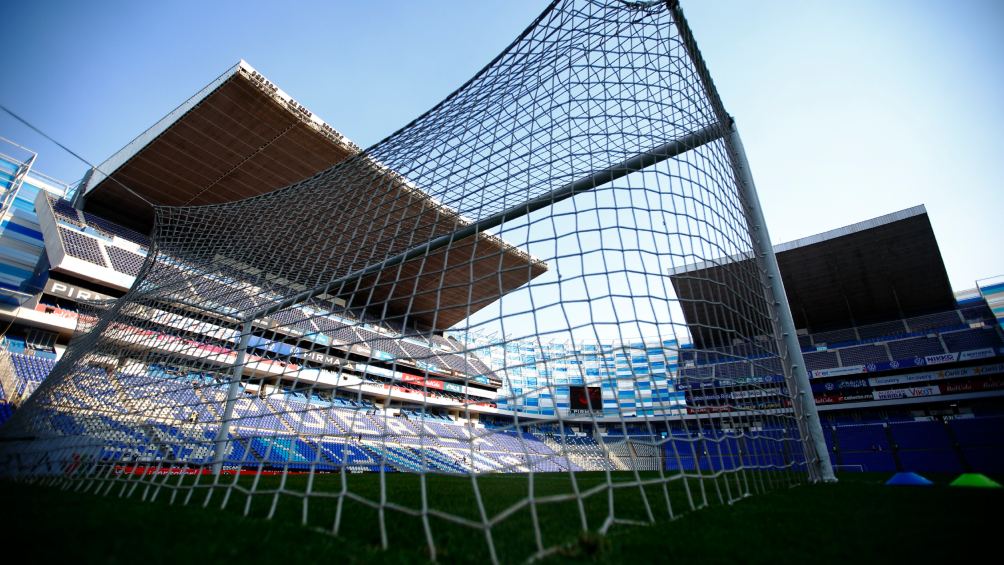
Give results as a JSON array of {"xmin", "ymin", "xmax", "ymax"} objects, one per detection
[{"xmin": 3, "ymin": 353, "xmax": 608, "ymax": 473}]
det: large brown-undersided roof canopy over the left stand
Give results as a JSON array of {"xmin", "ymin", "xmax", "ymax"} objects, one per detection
[{"xmin": 75, "ymin": 60, "xmax": 547, "ymax": 330}]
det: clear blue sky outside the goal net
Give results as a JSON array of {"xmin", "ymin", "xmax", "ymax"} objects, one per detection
[{"xmin": 0, "ymin": 0, "xmax": 1004, "ymax": 289}]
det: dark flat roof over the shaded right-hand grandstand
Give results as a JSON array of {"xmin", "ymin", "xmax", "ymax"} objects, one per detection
[{"xmin": 670, "ymin": 206, "xmax": 955, "ymax": 347}]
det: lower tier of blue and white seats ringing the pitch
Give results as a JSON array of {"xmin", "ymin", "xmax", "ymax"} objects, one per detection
[{"xmin": 3, "ymin": 327, "xmax": 1004, "ymax": 473}]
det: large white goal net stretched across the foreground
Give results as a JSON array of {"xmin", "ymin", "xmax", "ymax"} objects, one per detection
[{"xmin": 0, "ymin": 0, "xmax": 828, "ymax": 562}]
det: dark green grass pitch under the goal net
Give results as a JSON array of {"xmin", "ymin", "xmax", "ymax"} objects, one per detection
[{"xmin": 0, "ymin": 474, "xmax": 1004, "ymax": 564}]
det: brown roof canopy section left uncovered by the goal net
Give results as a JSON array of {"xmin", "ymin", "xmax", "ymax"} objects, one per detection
[{"xmin": 76, "ymin": 61, "xmax": 359, "ymax": 234}]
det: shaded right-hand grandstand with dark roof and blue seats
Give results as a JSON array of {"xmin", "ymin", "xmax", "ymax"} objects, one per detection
[{"xmin": 673, "ymin": 206, "xmax": 1004, "ymax": 473}]
